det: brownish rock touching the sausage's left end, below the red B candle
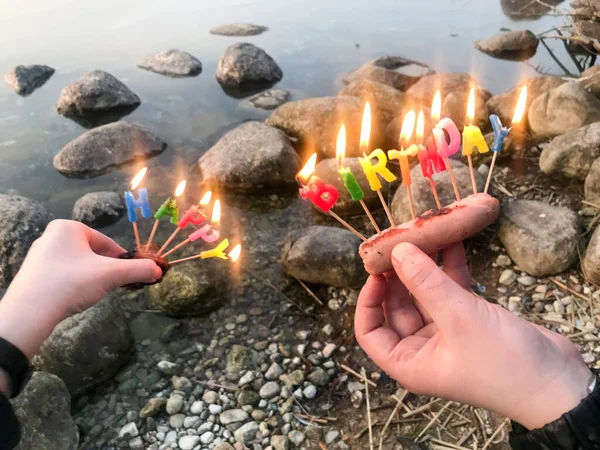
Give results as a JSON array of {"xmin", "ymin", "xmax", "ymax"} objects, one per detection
[{"xmin": 282, "ymin": 225, "xmax": 367, "ymax": 288}]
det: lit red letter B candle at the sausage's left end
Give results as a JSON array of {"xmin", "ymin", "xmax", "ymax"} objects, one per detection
[{"xmin": 296, "ymin": 153, "xmax": 367, "ymax": 241}]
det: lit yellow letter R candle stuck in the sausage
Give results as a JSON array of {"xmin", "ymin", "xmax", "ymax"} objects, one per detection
[{"xmin": 358, "ymin": 102, "xmax": 396, "ymax": 227}]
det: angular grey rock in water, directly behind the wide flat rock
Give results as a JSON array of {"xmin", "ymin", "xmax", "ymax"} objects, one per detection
[{"xmin": 56, "ymin": 70, "xmax": 141, "ymax": 118}]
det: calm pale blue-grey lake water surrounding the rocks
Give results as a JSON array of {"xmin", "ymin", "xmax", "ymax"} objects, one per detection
[{"xmin": 0, "ymin": 0, "xmax": 574, "ymax": 250}]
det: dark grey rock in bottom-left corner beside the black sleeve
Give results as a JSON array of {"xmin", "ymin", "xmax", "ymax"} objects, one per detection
[{"xmin": 11, "ymin": 372, "xmax": 79, "ymax": 450}]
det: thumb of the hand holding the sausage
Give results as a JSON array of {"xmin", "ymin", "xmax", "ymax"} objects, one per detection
[{"xmin": 392, "ymin": 242, "xmax": 475, "ymax": 330}]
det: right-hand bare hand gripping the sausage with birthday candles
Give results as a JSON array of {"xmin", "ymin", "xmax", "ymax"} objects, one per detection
[{"xmin": 355, "ymin": 243, "xmax": 591, "ymax": 429}]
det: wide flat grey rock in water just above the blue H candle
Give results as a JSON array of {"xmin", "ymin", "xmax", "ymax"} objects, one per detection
[{"xmin": 54, "ymin": 121, "xmax": 167, "ymax": 178}]
